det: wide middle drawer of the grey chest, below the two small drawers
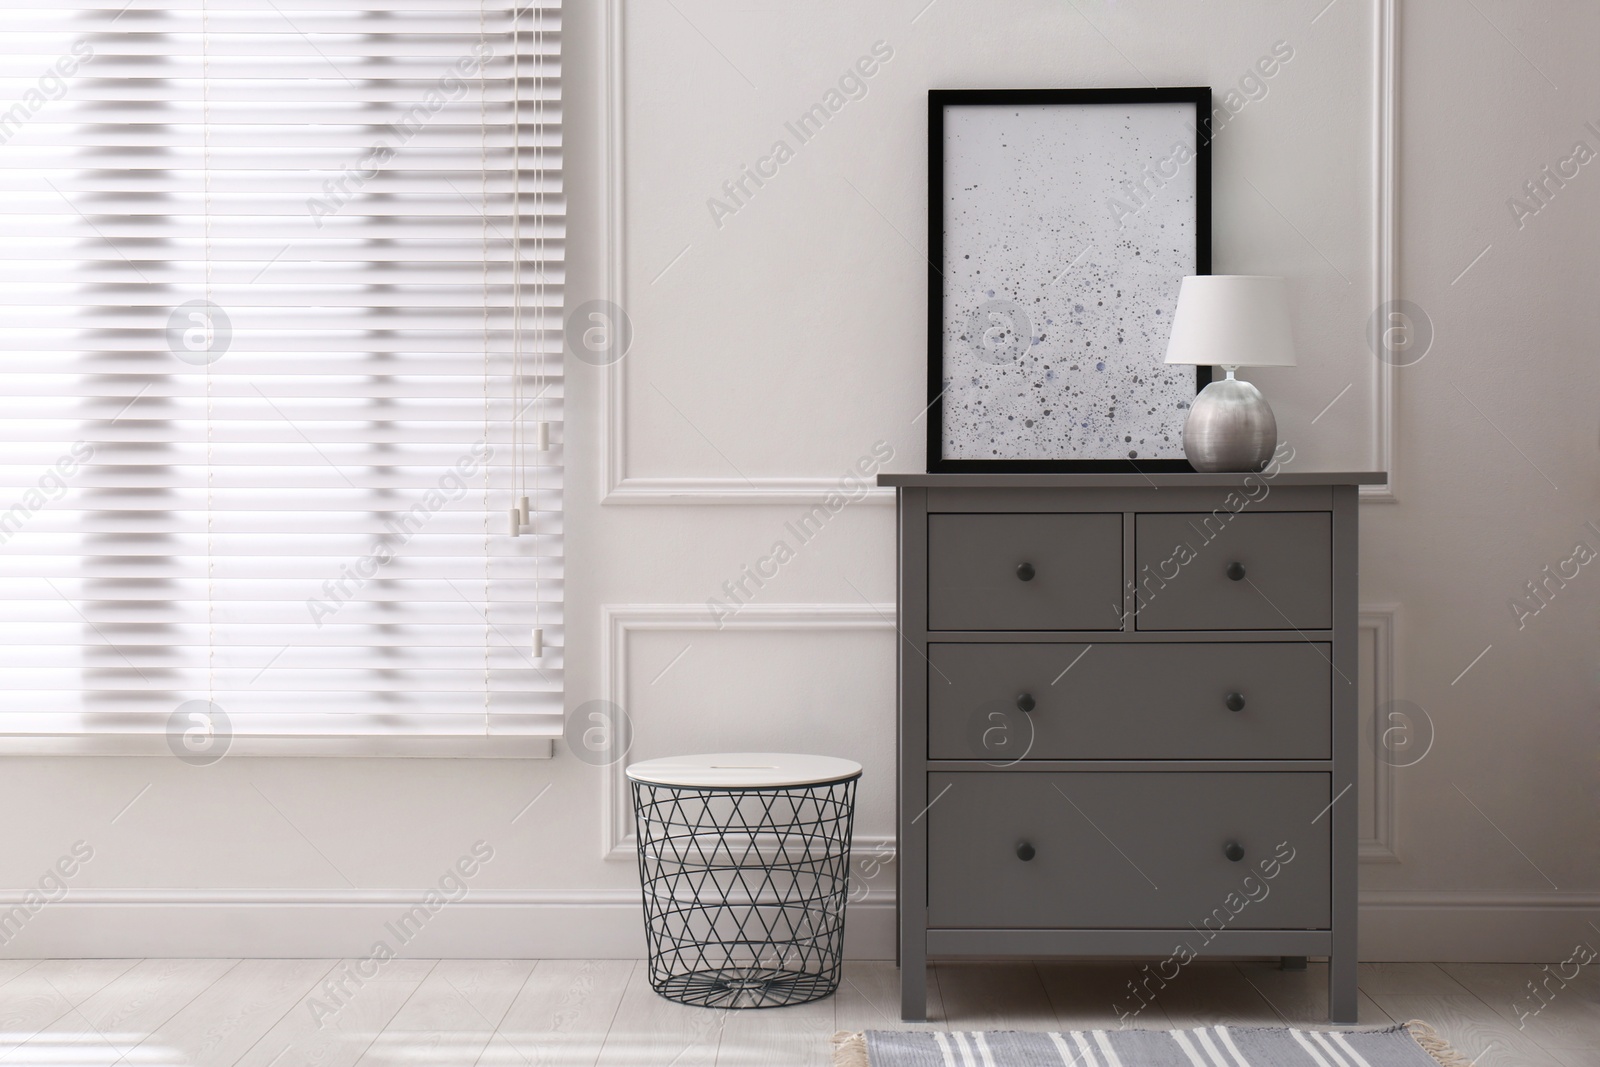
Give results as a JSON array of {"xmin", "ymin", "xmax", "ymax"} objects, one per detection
[{"xmin": 928, "ymin": 641, "xmax": 1333, "ymax": 763}]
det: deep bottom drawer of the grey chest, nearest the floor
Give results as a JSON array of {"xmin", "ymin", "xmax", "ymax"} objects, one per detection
[{"xmin": 926, "ymin": 771, "xmax": 1331, "ymax": 931}]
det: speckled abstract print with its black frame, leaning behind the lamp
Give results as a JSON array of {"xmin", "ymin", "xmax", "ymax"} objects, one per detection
[{"xmin": 926, "ymin": 88, "xmax": 1211, "ymax": 472}]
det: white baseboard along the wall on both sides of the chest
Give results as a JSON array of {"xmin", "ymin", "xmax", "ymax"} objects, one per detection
[{"xmin": 0, "ymin": 889, "xmax": 1600, "ymax": 963}]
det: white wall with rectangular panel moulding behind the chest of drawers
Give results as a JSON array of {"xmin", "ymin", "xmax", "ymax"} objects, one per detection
[{"xmin": 0, "ymin": 0, "xmax": 1600, "ymax": 960}]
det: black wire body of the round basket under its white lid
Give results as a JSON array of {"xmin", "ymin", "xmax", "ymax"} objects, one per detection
[{"xmin": 632, "ymin": 774, "xmax": 859, "ymax": 1008}]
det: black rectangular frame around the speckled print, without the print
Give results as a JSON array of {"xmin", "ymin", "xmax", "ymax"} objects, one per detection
[{"xmin": 925, "ymin": 86, "xmax": 1211, "ymax": 474}]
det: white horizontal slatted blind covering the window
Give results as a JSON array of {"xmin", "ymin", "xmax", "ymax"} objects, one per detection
[{"xmin": 0, "ymin": 0, "xmax": 565, "ymax": 755}]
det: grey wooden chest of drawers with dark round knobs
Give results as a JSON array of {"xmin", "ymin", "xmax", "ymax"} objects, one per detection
[{"xmin": 878, "ymin": 470, "xmax": 1384, "ymax": 1022}]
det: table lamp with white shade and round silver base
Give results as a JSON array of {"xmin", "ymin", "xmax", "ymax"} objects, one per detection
[{"xmin": 1166, "ymin": 274, "xmax": 1294, "ymax": 470}]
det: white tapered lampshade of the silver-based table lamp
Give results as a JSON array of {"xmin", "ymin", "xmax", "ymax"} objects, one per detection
[{"xmin": 1166, "ymin": 274, "xmax": 1294, "ymax": 366}]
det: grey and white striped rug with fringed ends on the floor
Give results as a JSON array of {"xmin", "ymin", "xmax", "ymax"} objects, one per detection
[{"xmin": 834, "ymin": 1022, "xmax": 1469, "ymax": 1067}]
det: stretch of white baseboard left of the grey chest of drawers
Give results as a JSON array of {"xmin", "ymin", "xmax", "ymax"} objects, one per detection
[{"xmin": 0, "ymin": 889, "xmax": 894, "ymax": 960}]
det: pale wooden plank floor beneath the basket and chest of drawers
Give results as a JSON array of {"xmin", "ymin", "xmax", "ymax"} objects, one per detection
[{"xmin": 0, "ymin": 960, "xmax": 1600, "ymax": 1067}]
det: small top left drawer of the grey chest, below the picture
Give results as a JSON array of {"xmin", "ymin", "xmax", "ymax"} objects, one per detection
[{"xmin": 928, "ymin": 514, "xmax": 1122, "ymax": 630}]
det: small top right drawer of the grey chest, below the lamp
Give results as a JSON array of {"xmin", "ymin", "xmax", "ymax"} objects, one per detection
[{"xmin": 1134, "ymin": 510, "xmax": 1333, "ymax": 630}]
